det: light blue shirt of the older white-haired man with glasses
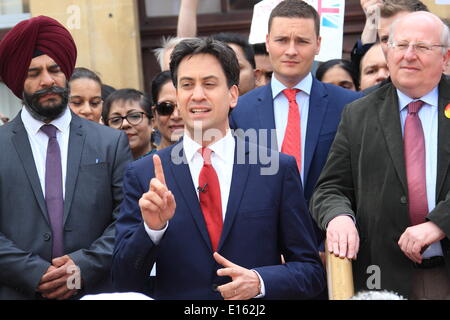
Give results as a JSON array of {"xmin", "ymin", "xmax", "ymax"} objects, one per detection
[{"xmin": 397, "ymin": 87, "xmax": 443, "ymax": 259}]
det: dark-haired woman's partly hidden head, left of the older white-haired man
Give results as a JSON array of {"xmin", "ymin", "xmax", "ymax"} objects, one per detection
[{"xmin": 316, "ymin": 59, "xmax": 359, "ymax": 91}]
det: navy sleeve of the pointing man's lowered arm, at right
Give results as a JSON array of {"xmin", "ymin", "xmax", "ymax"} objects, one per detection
[{"xmin": 254, "ymin": 157, "xmax": 325, "ymax": 299}]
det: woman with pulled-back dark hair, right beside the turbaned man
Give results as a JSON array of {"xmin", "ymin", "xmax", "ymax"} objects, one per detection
[{"xmin": 69, "ymin": 68, "xmax": 103, "ymax": 122}]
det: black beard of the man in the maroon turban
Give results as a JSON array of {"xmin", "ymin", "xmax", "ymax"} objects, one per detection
[{"xmin": 23, "ymin": 86, "xmax": 69, "ymax": 123}]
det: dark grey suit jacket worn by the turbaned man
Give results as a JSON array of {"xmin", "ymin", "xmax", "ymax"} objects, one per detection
[{"xmin": 0, "ymin": 113, "xmax": 131, "ymax": 299}]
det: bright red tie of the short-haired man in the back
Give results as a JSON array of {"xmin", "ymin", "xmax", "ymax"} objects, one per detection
[{"xmin": 281, "ymin": 89, "xmax": 302, "ymax": 171}]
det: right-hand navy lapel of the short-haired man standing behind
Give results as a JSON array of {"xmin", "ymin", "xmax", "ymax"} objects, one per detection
[{"xmin": 303, "ymin": 78, "xmax": 328, "ymax": 185}]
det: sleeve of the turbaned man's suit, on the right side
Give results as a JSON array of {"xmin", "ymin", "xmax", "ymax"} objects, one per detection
[{"xmin": 69, "ymin": 133, "xmax": 132, "ymax": 290}]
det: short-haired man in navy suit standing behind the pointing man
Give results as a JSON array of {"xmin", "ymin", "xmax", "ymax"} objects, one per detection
[{"xmin": 230, "ymin": 0, "xmax": 360, "ymax": 202}]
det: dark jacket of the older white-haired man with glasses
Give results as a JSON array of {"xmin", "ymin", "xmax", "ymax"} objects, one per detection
[{"xmin": 310, "ymin": 77, "xmax": 450, "ymax": 297}]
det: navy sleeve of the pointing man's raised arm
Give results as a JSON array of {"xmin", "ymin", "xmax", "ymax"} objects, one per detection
[{"xmin": 112, "ymin": 162, "xmax": 157, "ymax": 292}]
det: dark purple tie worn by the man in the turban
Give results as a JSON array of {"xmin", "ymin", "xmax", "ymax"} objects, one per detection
[{"xmin": 41, "ymin": 124, "xmax": 64, "ymax": 258}]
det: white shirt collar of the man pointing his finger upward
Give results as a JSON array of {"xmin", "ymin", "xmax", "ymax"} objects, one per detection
[{"xmin": 183, "ymin": 130, "xmax": 235, "ymax": 163}]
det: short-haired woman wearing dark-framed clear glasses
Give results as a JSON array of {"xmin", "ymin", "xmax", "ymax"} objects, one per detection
[{"xmin": 102, "ymin": 89, "xmax": 155, "ymax": 159}]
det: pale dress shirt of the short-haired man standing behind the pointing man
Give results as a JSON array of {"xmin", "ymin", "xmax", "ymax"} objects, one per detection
[{"xmin": 270, "ymin": 73, "xmax": 313, "ymax": 183}]
